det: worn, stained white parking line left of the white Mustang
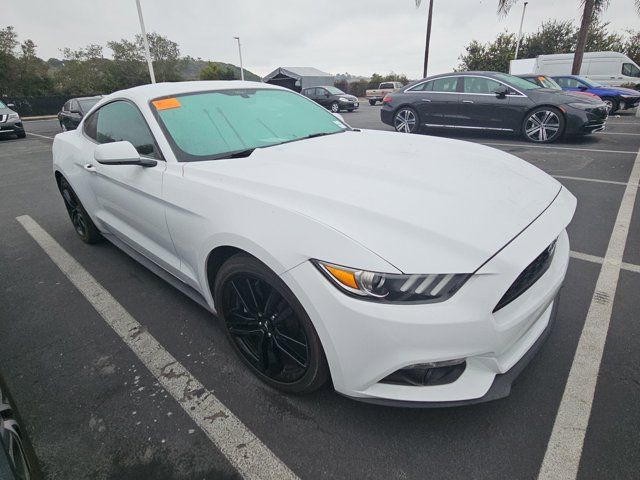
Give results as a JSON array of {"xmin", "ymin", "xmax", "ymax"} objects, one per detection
[{"xmin": 17, "ymin": 215, "xmax": 297, "ymax": 480}]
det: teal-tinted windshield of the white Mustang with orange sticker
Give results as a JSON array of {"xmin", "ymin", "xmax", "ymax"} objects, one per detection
[{"xmin": 151, "ymin": 88, "xmax": 349, "ymax": 162}]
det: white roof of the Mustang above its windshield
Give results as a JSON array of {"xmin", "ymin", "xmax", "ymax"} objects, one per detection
[{"xmin": 105, "ymin": 80, "xmax": 282, "ymax": 104}]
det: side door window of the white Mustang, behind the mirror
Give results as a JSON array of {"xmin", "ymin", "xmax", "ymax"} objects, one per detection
[{"xmin": 95, "ymin": 101, "xmax": 162, "ymax": 159}]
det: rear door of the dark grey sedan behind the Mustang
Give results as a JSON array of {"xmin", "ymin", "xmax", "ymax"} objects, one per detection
[{"xmin": 406, "ymin": 76, "xmax": 460, "ymax": 127}]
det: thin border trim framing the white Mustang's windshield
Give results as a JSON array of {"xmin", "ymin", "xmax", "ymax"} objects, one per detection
[{"xmin": 147, "ymin": 87, "xmax": 354, "ymax": 163}]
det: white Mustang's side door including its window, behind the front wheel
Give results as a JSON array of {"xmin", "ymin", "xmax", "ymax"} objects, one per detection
[{"xmin": 84, "ymin": 100, "xmax": 180, "ymax": 275}]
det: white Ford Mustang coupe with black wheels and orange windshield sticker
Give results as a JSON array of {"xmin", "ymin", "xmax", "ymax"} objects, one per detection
[{"xmin": 53, "ymin": 82, "xmax": 576, "ymax": 405}]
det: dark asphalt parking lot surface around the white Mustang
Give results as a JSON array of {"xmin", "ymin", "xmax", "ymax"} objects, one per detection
[{"xmin": 0, "ymin": 104, "xmax": 640, "ymax": 480}]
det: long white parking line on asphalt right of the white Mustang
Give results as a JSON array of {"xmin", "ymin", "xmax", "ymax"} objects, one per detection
[{"xmin": 538, "ymin": 147, "xmax": 640, "ymax": 480}]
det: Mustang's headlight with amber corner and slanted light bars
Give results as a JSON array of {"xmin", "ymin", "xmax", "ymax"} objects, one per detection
[{"xmin": 312, "ymin": 260, "xmax": 471, "ymax": 303}]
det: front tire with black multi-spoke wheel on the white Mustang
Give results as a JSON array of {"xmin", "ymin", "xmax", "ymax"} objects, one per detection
[{"xmin": 214, "ymin": 254, "xmax": 329, "ymax": 394}]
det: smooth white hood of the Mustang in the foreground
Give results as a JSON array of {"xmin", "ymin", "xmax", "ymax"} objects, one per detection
[{"xmin": 184, "ymin": 130, "xmax": 562, "ymax": 273}]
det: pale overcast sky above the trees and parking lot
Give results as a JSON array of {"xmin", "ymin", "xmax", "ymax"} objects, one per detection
[{"xmin": 6, "ymin": 0, "xmax": 640, "ymax": 78}]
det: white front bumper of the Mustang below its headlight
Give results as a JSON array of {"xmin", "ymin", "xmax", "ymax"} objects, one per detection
[{"xmin": 282, "ymin": 189, "xmax": 575, "ymax": 406}]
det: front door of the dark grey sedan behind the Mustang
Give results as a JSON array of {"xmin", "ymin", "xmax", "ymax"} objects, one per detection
[{"xmin": 459, "ymin": 75, "xmax": 515, "ymax": 130}]
